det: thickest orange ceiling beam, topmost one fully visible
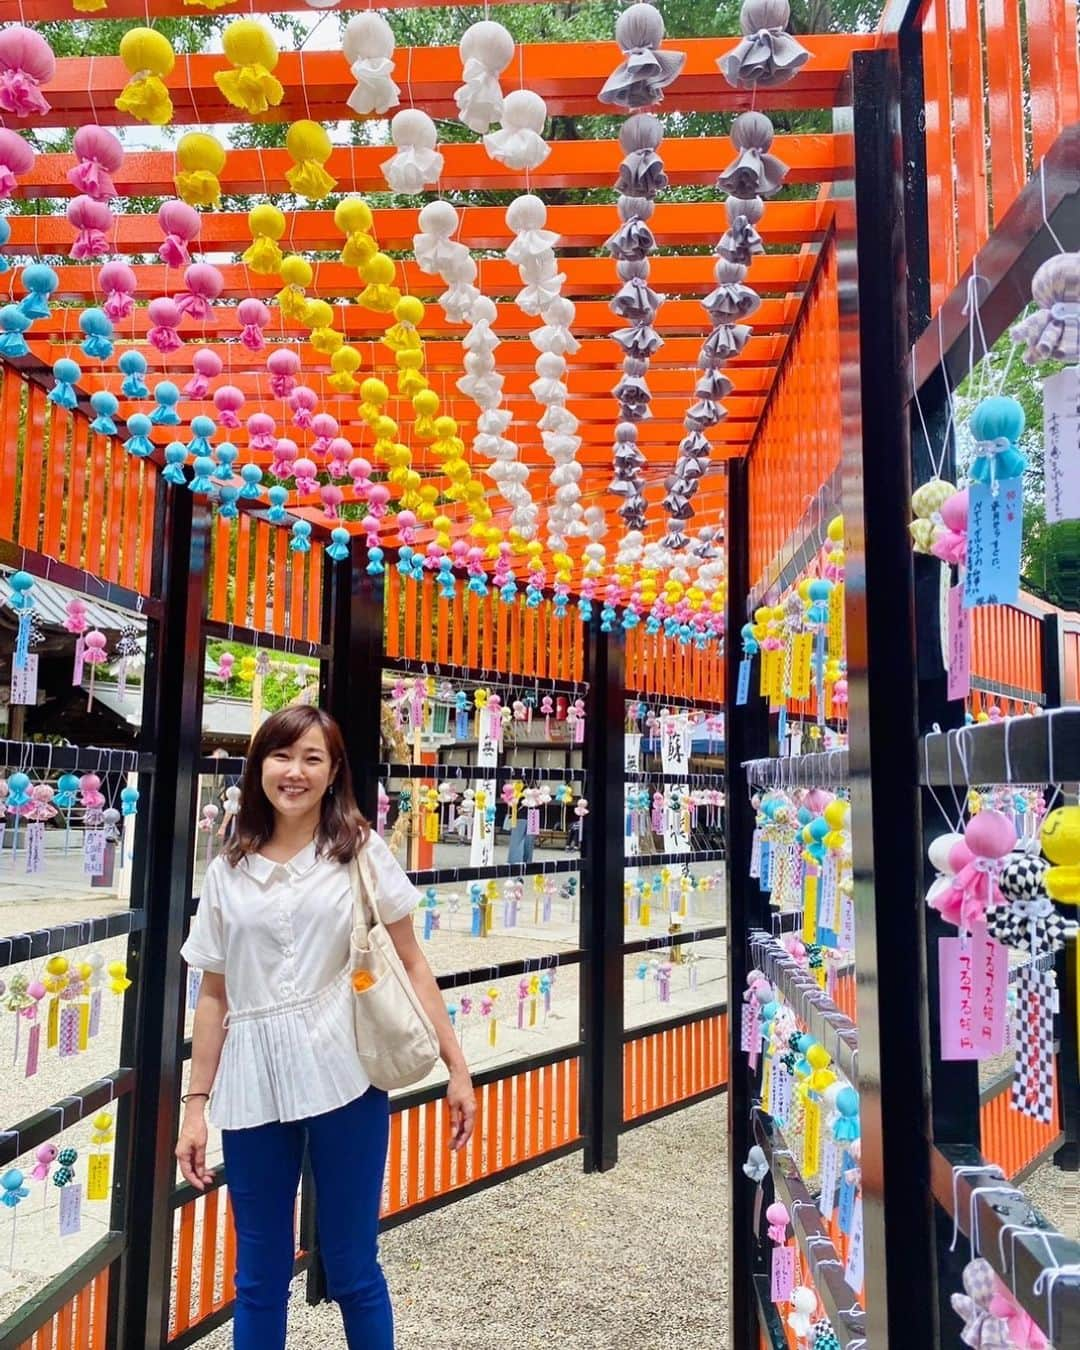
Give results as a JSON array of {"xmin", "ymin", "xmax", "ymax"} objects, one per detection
[{"xmin": 0, "ymin": 36, "xmax": 875, "ymax": 127}]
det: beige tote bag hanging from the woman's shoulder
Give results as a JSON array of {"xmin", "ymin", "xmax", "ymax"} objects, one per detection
[{"xmin": 350, "ymin": 848, "xmax": 439, "ymax": 1092}]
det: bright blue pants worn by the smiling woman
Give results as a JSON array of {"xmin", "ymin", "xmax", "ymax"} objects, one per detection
[{"xmin": 221, "ymin": 1088, "xmax": 394, "ymax": 1350}]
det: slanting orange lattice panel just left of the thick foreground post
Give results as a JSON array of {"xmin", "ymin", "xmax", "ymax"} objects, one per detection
[{"xmin": 749, "ymin": 238, "xmax": 841, "ymax": 583}]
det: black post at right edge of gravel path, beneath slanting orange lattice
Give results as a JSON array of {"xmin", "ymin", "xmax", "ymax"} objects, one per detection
[{"xmin": 724, "ymin": 447, "xmax": 770, "ymax": 1350}]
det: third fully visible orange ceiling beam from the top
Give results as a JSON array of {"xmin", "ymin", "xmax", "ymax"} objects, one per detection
[{"xmin": 3, "ymin": 198, "xmax": 834, "ymax": 255}]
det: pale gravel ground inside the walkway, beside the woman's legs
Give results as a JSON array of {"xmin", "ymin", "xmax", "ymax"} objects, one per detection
[{"xmin": 191, "ymin": 1098, "xmax": 728, "ymax": 1350}]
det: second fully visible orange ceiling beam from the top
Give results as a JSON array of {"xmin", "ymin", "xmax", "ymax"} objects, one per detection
[{"xmin": 15, "ymin": 135, "xmax": 852, "ymax": 197}]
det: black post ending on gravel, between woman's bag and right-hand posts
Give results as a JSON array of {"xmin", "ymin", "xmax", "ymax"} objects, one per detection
[{"xmin": 581, "ymin": 617, "xmax": 626, "ymax": 1172}]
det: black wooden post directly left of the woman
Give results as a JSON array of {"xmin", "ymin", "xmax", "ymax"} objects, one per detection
[{"xmin": 111, "ymin": 487, "xmax": 209, "ymax": 1350}]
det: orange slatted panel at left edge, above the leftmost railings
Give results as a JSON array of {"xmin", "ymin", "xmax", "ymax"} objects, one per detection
[{"xmin": 0, "ymin": 362, "xmax": 158, "ymax": 595}]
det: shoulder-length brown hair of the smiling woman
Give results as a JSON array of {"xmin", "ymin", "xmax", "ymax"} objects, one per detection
[{"xmin": 224, "ymin": 705, "xmax": 369, "ymax": 867}]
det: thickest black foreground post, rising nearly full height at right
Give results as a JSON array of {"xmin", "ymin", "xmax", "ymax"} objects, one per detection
[{"xmin": 841, "ymin": 51, "xmax": 937, "ymax": 1350}]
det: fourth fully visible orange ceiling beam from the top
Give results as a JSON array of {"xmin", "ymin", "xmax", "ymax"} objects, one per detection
[{"xmin": 25, "ymin": 248, "xmax": 815, "ymax": 302}]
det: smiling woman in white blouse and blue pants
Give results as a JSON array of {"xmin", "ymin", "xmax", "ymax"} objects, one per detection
[{"xmin": 176, "ymin": 706, "xmax": 475, "ymax": 1350}]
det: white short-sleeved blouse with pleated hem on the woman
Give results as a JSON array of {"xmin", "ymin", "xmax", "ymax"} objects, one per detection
[{"xmin": 181, "ymin": 830, "xmax": 420, "ymax": 1130}]
